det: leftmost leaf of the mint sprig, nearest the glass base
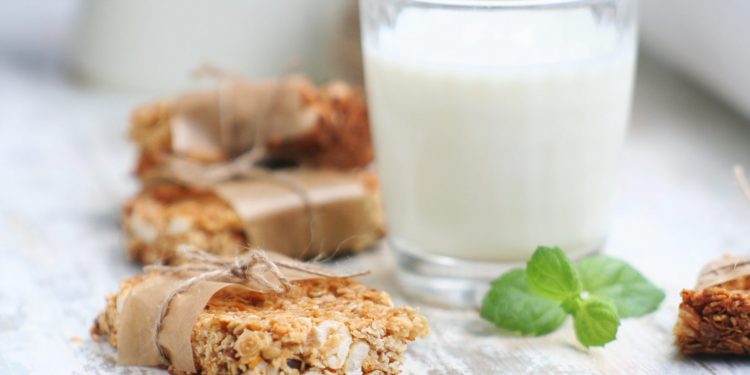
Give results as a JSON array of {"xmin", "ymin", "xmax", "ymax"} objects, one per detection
[{"xmin": 481, "ymin": 269, "xmax": 566, "ymax": 336}]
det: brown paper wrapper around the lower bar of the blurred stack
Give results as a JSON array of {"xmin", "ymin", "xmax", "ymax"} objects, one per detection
[{"xmin": 213, "ymin": 169, "xmax": 382, "ymax": 257}]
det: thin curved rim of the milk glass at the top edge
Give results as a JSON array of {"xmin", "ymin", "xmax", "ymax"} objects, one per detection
[{"xmin": 405, "ymin": 0, "xmax": 622, "ymax": 10}]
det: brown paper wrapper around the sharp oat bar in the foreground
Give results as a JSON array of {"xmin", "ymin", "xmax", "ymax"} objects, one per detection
[{"xmin": 117, "ymin": 253, "xmax": 350, "ymax": 373}]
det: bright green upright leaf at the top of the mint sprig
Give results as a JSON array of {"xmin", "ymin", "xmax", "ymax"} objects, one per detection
[{"xmin": 526, "ymin": 246, "xmax": 582, "ymax": 302}]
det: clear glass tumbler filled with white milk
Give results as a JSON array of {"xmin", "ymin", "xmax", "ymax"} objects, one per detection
[{"xmin": 360, "ymin": 0, "xmax": 636, "ymax": 305}]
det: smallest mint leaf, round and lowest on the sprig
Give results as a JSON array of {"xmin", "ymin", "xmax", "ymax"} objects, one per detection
[{"xmin": 573, "ymin": 297, "xmax": 620, "ymax": 348}]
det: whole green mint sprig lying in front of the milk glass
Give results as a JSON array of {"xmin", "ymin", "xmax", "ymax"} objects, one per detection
[{"xmin": 481, "ymin": 247, "xmax": 664, "ymax": 347}]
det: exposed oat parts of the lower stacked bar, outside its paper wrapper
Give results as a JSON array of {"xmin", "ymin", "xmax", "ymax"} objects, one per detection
[{"xmin": 122, "ymin": 178, "xmax": 385, "ymax": 264}]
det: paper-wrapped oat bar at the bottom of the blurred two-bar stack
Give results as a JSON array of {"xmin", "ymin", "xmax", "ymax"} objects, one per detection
[{"xmin": 122, "ymin": 170, "xmax": 385, "ymax": 264}]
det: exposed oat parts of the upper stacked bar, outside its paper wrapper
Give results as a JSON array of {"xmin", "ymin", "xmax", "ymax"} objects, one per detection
[{"xmin": 130, "ymin": 82, "xmax": 373, "ymax": 180}]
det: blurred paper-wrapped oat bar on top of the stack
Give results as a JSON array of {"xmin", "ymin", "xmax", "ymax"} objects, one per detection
[{"xmin": 130, "ymin": 77, "xmax": 373, "ymax": 180}]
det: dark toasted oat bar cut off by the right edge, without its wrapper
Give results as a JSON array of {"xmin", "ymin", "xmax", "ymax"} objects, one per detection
[{"xmin": 674, "ymin": 277, "xmax": 750, "ymax": 355}]
